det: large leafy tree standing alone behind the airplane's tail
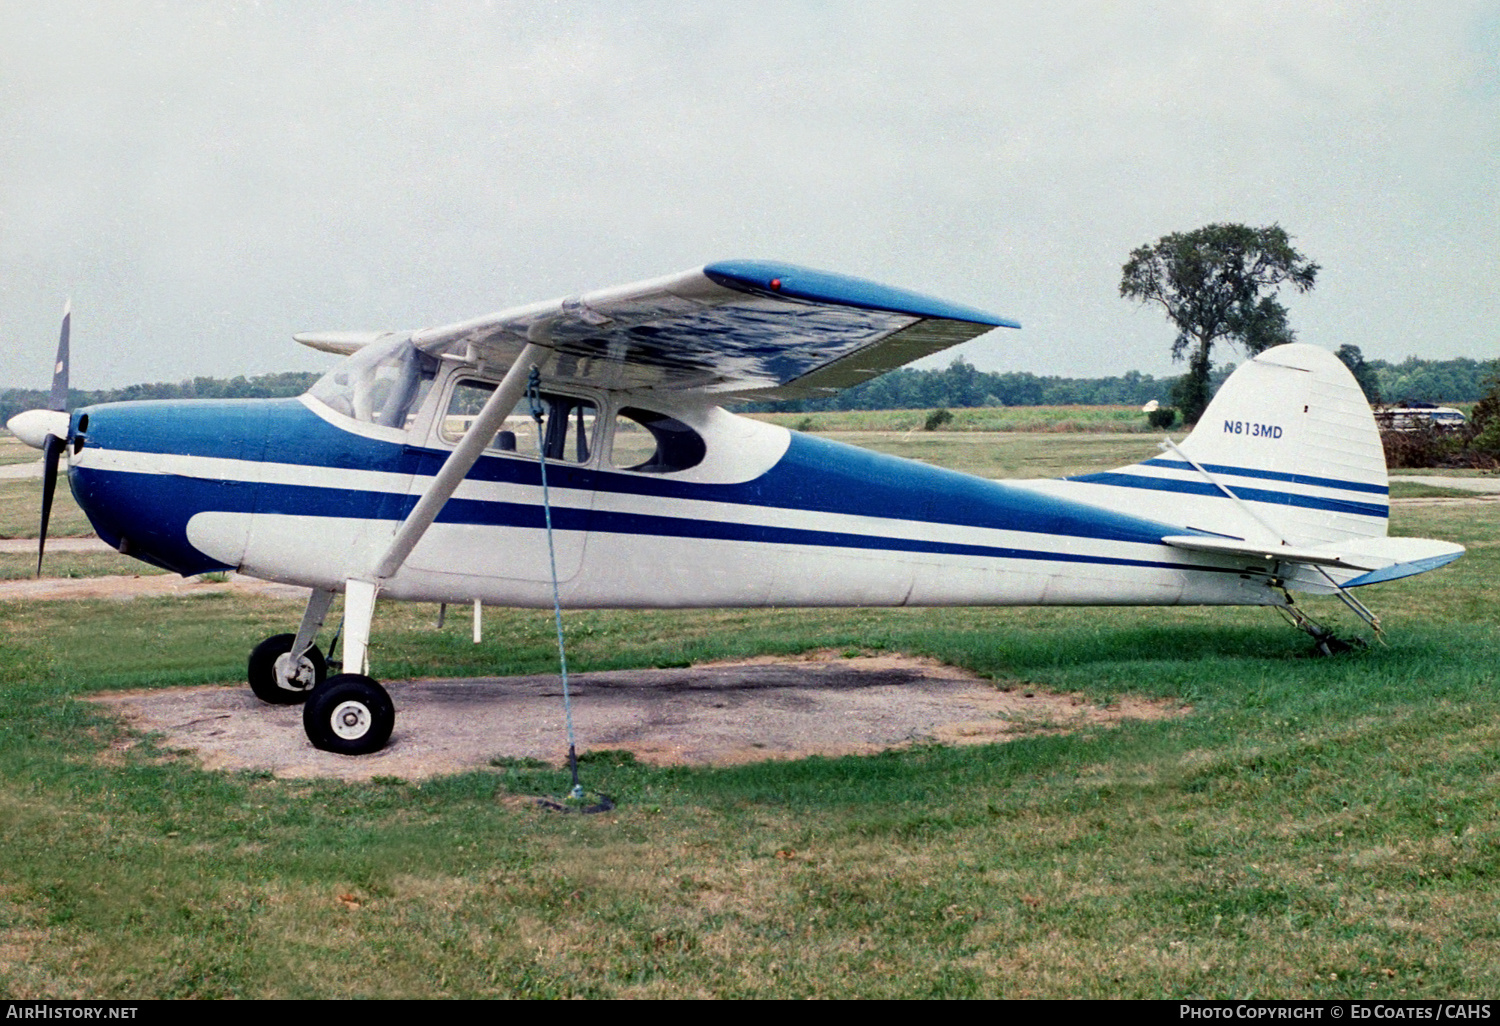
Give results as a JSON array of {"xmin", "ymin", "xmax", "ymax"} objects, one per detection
[{"xmin": 1121, "ymin": 225, "xmax": 1319, "ymax": 423}]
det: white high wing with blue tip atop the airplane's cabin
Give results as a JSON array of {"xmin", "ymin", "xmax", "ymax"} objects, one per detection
[{"xmin": 296, "ymin": 261, "xmax": 1020, "ymax": 399}]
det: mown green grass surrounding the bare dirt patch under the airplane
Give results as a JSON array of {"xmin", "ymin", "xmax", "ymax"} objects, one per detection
[{"xmin": 0, "ymin": 432, "xmax": 1500, "ymax": 999}]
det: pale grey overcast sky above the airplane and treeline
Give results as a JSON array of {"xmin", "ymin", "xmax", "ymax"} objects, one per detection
[{"xmin": 0, "ymin": 0, "xmax": 1500, "ymax": 389}]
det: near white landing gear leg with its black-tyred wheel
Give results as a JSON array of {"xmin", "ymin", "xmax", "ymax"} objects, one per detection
[{"xmin": 302, "ymin": 581, "xmax": 396, "ymax": 755}]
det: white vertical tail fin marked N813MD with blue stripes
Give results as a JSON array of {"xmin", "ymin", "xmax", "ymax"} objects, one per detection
[{"xmin": 1043, "ymin": 345, "xmax": 1391, "ymax": 546}]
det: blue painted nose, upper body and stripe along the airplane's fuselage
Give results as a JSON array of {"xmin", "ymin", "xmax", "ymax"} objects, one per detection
[{"xmin": 72, "ymin": 401, "xmax": 1326, "ymax": 573}]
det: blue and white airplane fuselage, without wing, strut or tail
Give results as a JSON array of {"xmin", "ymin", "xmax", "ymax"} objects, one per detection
[{"xmin": 69, "ymin": 364, "xmax": 1281, "ymax": 608}]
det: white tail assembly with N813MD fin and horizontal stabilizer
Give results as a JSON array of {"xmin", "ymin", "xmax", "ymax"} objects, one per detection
[{"xmin": 1008, "ymin": 345, "xmax": 1464, "ymax": 594}]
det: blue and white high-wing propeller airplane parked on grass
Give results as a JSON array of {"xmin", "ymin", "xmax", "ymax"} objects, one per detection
[{"xmin": 9, "ymin": 261, "xmax": 1463, "ymax": 755}]
